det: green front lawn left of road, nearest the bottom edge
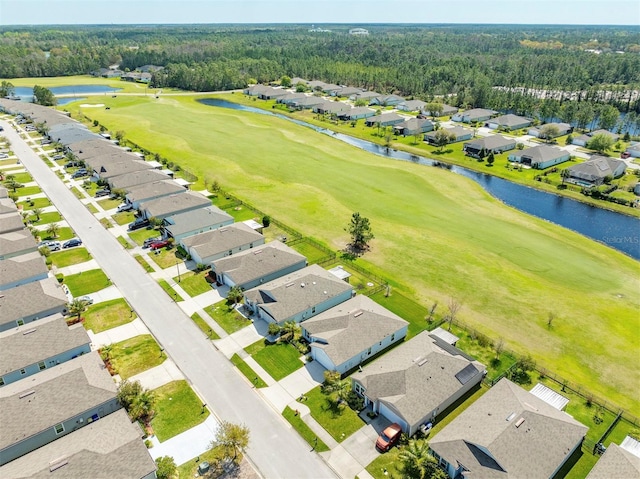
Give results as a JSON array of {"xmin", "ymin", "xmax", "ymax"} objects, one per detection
[{"xmin": 151, "ymin": 380, "xmax": 209, "ymax": 442}]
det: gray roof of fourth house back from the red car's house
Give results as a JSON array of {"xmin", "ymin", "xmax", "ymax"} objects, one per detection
[{"xmin": 211, "ymin": 241, "xmax": 306, "ymax": 284}]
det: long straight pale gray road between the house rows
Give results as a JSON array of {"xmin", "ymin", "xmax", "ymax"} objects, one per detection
[{"xmin": 0, "ymin": 120, "xmax": 337, "ymax": 479}]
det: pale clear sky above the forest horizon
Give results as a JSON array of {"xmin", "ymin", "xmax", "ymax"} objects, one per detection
[{"xmin": 0, "ymin": 0, "xmax": 640, "ymax": 26}]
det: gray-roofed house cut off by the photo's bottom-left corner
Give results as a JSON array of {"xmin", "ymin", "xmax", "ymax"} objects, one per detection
[{"xmin": 0, "ymin": 409, "xmax": 156, "ymax": 479}]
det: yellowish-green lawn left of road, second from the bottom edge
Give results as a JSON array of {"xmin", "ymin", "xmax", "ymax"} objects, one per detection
[{"xmin": 111, "ymin": 334, "xmax": 167, "ymax": 379}]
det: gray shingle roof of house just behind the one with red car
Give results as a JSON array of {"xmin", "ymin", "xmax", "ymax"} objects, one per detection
[{"xmin": 302, "ymin": 295, "xmax": 409, "ymax": 365}]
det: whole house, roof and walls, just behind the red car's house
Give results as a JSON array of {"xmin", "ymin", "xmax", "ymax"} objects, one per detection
[{"xmin": 302, "ymin": 294, "xmax": 409, "ymax": 375}]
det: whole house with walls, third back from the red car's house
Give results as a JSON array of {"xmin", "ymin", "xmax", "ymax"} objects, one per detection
[{"xmin": 244, "ymin": 264, "xmax": 353, "ymax": 325}]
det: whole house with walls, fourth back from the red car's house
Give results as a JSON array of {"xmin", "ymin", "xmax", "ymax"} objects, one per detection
[{"xmin": 210, "ymin": 241, "xmax": 307, "ymax": 290}]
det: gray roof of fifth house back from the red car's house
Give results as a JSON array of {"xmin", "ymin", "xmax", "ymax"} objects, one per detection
[{"xmin": 182, "ymin": 223, "xmax": 264, "ymax": 258}]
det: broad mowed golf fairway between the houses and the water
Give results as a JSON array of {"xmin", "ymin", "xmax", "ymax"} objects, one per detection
[{"xmin": 69, "ymin": 96, "xmax": 640, "ymax": 415}]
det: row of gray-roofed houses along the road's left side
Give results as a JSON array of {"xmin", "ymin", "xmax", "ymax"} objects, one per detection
[{"xmin": 0, "ymin": 179, "xmax": 156, "ymax": 479}]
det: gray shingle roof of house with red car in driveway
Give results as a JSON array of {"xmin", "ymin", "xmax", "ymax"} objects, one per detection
[{"xmin": 352, "ymin": 331, "xmax": 485, "ymax": 424}]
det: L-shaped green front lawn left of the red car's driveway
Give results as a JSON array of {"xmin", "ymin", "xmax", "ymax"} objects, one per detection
[{"xmin": 304, "ymin": 386, "xmax": 364, "ymax": 442}]
